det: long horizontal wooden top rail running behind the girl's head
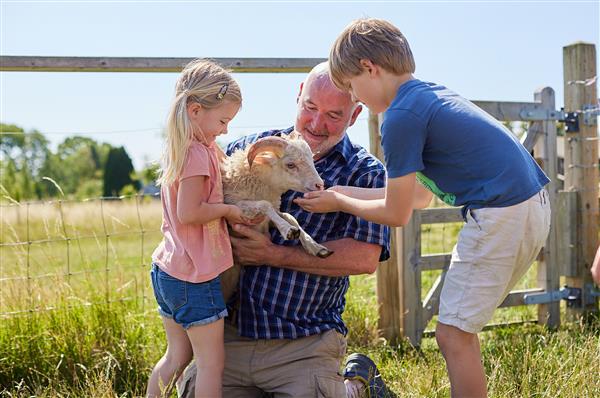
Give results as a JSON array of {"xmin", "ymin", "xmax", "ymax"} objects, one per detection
[{"xmin": 0, "ymin": 55, "xmax": 327, "ymax": 73}]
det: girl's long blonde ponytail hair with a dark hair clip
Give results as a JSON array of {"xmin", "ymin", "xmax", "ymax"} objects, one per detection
[{"xmin": 157, "ymin": 59, "xmax": 242, "ymax": 185}]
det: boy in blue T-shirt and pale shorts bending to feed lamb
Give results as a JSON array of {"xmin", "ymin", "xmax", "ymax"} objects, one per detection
[{"xmin": 296, "ymin": 19, "xmax": 550, "ymax": 397}]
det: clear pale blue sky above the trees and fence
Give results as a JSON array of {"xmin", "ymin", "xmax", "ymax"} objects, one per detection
[{"xmin": 0, "ymin": 0, "xmax": 600, "ymax": 168}]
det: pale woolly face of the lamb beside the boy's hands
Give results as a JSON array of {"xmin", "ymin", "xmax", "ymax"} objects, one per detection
[{"xmin": 272, "ymin": 139, "xmax": 324, "ymax": 192}]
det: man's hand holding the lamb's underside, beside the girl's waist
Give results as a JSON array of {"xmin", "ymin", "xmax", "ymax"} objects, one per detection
[{"xmin": 230, "ymin": 224, "xmax": 277, "ymax": 265}]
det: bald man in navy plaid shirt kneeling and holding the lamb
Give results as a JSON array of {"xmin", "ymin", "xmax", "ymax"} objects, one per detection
[{"xmin": 180, "ymin": 63, "xmax": 389, "ymax": 398}]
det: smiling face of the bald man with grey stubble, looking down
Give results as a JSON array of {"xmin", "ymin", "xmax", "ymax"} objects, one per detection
[{"xmin": 295, "ymin": 70, "xmax": 361, "ymax": 159}]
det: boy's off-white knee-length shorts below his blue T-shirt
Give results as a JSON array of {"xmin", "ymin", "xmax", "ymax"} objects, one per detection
[{"xmin": 438, "ymin": 189, "xmax": 550, "ymax": 333}]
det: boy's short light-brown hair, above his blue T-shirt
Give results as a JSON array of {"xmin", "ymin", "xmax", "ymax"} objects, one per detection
[{"xmin": 329, "ymin": 18, "xmax": 415, "ymax": 90}]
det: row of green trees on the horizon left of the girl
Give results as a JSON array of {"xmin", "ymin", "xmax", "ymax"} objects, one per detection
[{"xmin": 0, "ymin": 123, "xmax": 156, "ymax": 202}]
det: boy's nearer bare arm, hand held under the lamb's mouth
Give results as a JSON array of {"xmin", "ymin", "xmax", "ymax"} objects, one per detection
[{"xmin": 294, "ymin": 173, "xmax": 418, "ymax": 227}]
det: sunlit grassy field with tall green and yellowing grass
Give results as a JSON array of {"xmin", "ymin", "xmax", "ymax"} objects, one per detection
[{"xmin": 0, "ymin": 199, "xmax": 600, "ymax": 397}]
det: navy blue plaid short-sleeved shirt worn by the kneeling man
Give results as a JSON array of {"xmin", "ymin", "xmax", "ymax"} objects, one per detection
[{"xmin": 227, "ymin": 128, "xmax": 390, "ymax": 339}]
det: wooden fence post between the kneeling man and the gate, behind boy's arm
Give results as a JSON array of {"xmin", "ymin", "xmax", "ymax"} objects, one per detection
[{"xmin": 369, "ymin": 111, "xmax": 402, "ymax": 344}]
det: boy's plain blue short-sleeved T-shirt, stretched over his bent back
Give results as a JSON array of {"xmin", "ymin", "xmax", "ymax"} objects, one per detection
[{"xmin": 381, "ymin": 79, "xmax": 550, "ymax": 212}]
